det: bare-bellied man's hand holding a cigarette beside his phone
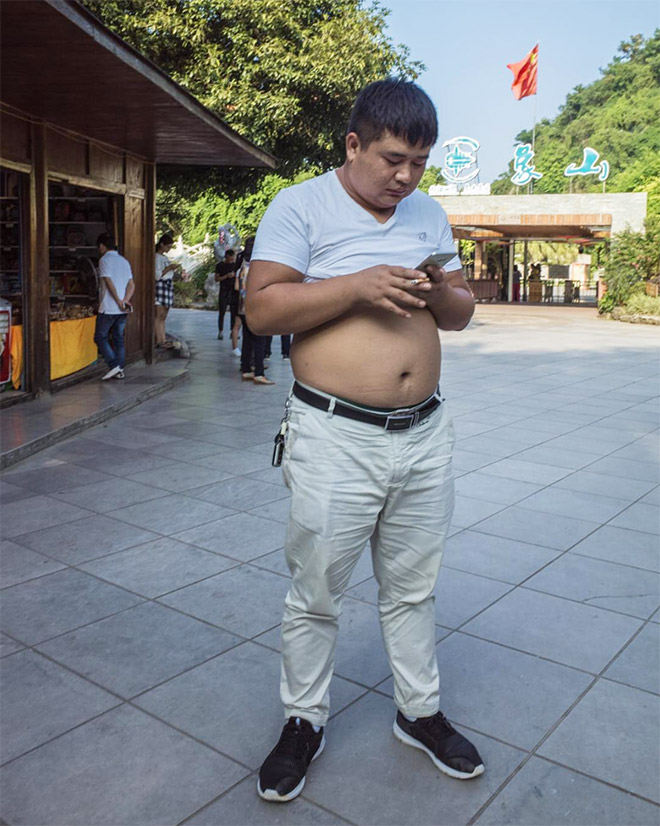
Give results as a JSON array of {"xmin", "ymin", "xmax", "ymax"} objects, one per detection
[{"xmin": 348, "ymin": 264, "xmax": 431, "ymax": 318}]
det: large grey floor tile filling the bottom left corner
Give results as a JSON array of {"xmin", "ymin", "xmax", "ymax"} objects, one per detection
[{"xmin": 2, "ymin": 706, "xmax": 247, "ymax": 826}]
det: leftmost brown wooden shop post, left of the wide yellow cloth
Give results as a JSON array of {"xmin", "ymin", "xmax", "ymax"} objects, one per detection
[{"xmin": 28, "ymin": 123, "xmax": 50, "ymax": 394}]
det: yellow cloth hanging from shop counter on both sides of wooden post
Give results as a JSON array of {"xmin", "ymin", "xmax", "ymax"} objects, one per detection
[{"xmin": 11, "ymin": 316, "xmax": 98, "ymax": 390}]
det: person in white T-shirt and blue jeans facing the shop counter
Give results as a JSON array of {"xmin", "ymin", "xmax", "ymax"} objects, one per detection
[{"xmin": 94, "ymin": 232, "xmax": 135, "ymax": 381}]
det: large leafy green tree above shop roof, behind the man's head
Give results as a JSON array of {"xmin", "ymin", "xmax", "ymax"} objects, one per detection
[{"xmin": 84, "ymin": 0, "xmax": 423, "ymax": 175}]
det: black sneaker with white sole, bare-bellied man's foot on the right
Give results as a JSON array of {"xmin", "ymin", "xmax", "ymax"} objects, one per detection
[{"xmin": 394, "ymin": 711, "xmax": 484, "ymax": 780}]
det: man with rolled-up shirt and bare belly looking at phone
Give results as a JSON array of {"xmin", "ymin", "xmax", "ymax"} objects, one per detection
[{"xmin": 247, "ymin": 80, "xmax": 483, "ymax": 802}]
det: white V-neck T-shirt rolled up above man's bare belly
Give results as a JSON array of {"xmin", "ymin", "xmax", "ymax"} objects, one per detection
[{"xmin": 252, "ymin": 171, "xmax": 461, "ymax": 281}]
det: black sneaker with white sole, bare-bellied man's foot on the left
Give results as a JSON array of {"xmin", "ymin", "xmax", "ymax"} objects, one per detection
[{"xmin": 257, "ymin": 717, "xmax": 325, "ymax": 803}]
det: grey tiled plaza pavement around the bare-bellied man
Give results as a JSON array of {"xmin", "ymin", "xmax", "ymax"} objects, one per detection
[{"xmin": 0, "ymin": 306, "xmax": 660, "ymax": 826}]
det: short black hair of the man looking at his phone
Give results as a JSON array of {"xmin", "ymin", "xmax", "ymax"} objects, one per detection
[{"xmin": 346, "ymin": 78, "xmax": 438, "ymax": 148}]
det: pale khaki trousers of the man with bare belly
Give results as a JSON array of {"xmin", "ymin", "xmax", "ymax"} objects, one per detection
[{"xmin": 281, "ymin": 397, "xmax": 454, "ymax": 726}]
